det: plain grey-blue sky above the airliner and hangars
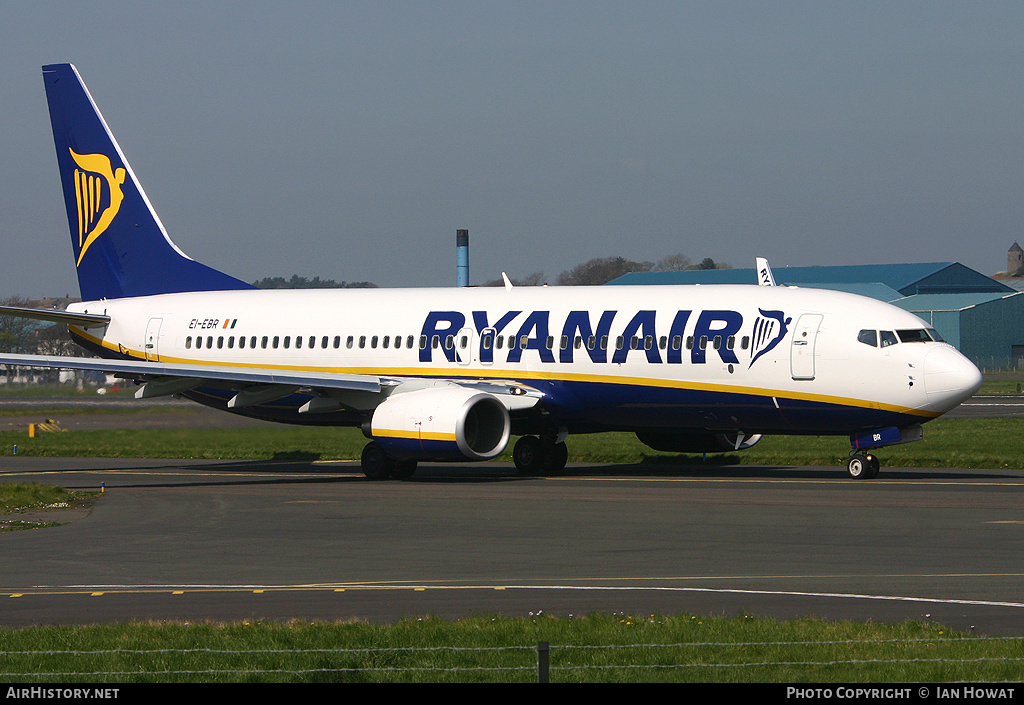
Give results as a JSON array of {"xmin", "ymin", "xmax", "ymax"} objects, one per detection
[{"xmin": 0, "ymin": 0, "xmax": 1024, "ymax": 297}]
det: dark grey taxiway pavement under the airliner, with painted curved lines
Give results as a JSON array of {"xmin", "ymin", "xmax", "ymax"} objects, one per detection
[{"xmin": 0, "ymin": 457, "xmax": 1024, "ymax": 634}]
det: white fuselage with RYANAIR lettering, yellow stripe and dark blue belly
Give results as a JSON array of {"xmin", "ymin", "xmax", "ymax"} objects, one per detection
[{"xmin": 70, "ymin": 278, "xmax": 976, "ymax": 433}]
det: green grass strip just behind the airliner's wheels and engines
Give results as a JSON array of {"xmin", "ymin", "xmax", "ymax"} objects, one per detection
[{"xmin": 0, "ymin": 418, "xmax": 1024, "ymax": 469}]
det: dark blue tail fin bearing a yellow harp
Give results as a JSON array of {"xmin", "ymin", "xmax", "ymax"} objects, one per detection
[{"xmin": 43, "ymin": 64, "xmax": 253, "ymax": 301}]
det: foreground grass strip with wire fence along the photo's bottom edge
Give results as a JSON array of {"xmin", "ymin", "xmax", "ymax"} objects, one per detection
[{"xmin": 0, "ymin": 614, "xmax": 1024, "ymax": 683}]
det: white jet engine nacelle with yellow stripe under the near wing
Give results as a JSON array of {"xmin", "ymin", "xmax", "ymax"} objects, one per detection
[{"xmin": 370, "ymin": 385, "xmax": 512, "ymax": 460}]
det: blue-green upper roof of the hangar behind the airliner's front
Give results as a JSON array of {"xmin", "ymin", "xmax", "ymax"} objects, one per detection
[{"xmin": 608, "ymin": 262, "xmax": 1014, "ymax": 300}]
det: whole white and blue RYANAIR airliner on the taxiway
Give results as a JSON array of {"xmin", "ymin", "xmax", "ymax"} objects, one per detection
[{"xmin": 0, "ymin": 65, "xmax": 981, "ymax": 479}]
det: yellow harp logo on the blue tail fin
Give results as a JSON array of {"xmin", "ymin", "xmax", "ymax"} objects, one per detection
[{"xmin": 69, "ymin": 150, "xmax": 125, "ymax": 266}]
